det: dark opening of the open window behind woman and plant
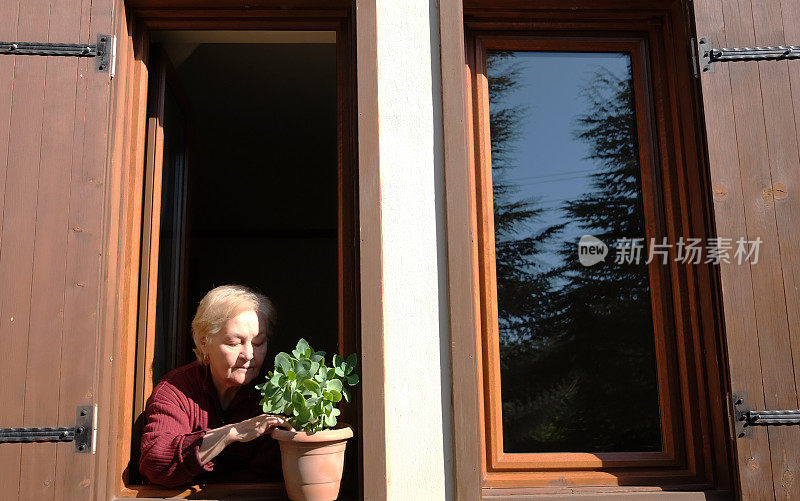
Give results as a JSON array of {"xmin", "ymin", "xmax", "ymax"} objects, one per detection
[{"xmin": 123, "ymin": 29, "xmax": 360, "ymax": 498}]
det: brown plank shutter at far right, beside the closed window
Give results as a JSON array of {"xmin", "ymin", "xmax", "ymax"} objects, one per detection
[{"xmin": 694, "ymin": 0, "xmax": 800, "ymax": 499}]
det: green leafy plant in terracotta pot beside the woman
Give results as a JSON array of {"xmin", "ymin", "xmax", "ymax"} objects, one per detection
[{"xmin": 256, "ymin": 339, "xmax": 358, "ymax": 501}]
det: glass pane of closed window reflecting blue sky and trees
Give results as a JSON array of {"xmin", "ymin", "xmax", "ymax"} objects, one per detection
[{"xmin": 487, "ymin": 51, "xmax": 662, "ymax": 452}]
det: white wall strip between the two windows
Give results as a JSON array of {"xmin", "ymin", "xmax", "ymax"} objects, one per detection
[{"xmin": 374, "ymin": 0, "xmax": 453, "ymax": 501}]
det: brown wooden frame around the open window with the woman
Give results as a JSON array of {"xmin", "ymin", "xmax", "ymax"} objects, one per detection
[{"xmin": 95, "ymin": 0, "xmax": 386, "ymax": 499}]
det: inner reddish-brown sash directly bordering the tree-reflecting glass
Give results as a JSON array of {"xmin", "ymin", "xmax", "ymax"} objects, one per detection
[{"xmin": 470, "ymin": 33, "xmax": 684, "ymax": 471}]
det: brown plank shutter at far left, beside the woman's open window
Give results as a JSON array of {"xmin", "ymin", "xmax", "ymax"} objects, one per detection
[{"xmin": 0, "ymin": 0, "xmax": 111, "ymax": 500}]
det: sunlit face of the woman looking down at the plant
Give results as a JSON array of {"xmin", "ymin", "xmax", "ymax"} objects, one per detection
[{"xmin": 206, "ymin": 309, "xmax": 267, "ymax": 390}]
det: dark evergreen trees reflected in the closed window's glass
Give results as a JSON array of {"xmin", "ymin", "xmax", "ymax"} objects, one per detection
[{"xmin": 494, "ymin": 52, "xmax": 661, "ymax": 452}]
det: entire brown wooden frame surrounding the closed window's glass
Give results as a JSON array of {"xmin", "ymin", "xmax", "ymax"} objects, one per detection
[{"xmin": 440, "ymin": 0, "xmax": 731, "ymax": 499}]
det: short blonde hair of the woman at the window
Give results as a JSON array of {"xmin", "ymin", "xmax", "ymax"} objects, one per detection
[{"xmin": 192, "ymin": 285, "xmax": 276, "ymax": 364}]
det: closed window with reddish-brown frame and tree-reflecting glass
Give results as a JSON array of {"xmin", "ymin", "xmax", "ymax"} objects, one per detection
[{"xmin": 460, "ymin": 2, "xmax": 727, "ymax": 495}]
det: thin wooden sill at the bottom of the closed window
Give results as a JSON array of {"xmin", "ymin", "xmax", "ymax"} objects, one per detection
[{"xmin": 481, "ymin": 487, "xmax": 733, "ymax": 501}]
